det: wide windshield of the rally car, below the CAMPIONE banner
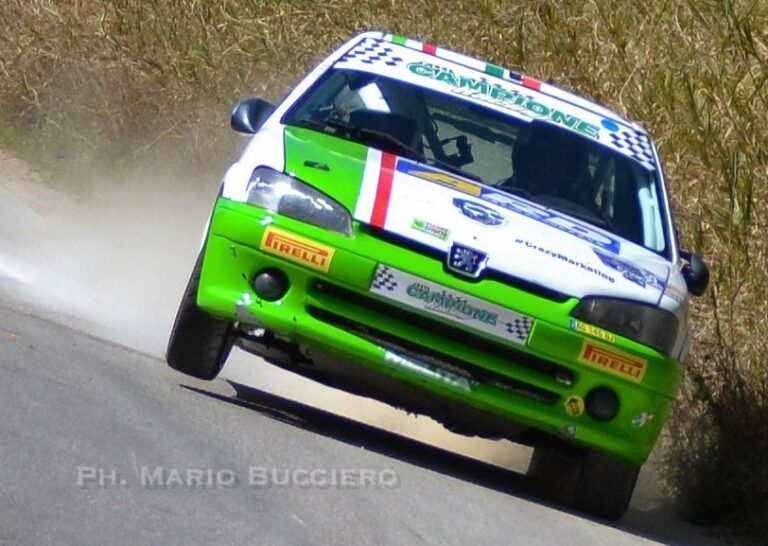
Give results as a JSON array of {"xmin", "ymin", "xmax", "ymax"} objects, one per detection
[{"xmin": 283, "ymin": 69, "xmax": 666, "ymax": 252}]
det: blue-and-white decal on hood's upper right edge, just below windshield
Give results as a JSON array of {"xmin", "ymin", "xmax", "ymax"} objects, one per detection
[{"xmin": 480, "ymin": 188, "xmax": 621, "ymax": 254}]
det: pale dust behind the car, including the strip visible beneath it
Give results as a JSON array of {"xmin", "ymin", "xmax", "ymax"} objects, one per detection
[{"xmin": 0, "ymin": 147, "xmax": 530, "ymax": 472}]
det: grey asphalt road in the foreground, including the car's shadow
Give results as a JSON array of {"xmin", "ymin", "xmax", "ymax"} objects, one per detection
[{"xmin": 0, "ymin": 296, "xmax": 732, "ymax": 545}]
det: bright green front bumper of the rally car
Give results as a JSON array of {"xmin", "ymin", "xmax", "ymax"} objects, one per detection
[{"xmin": 198, "ymin": 199, "xmax": 679, "ymax": 465}]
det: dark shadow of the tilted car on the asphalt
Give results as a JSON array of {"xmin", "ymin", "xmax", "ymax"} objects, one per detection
[{"xmin": 180, "ymin": 380, "xmax": 720, "ymax": 545}]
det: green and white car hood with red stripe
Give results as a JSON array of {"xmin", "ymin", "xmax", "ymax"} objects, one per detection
[{"xmin": 285, "ymin": 128, "xmax": 672, "ymax": 305}]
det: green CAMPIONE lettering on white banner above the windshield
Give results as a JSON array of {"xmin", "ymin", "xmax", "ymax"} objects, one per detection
[{"xmin": 408, "ymin": 62, "xmax": 600, "ymax": 139}]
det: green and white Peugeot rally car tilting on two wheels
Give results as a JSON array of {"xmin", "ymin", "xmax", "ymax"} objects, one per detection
[{"xmin": 167, "ymin": 32, "xmax": 708, "ymax": 518}]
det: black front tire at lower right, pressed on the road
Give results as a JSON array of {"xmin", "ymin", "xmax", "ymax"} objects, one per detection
[{"xmin": 573, "ymin": 451, "xmax": 640, "ymax": 520}]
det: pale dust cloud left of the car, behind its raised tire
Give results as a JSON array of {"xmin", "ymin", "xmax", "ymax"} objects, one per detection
[{"xmin": 0, "ymin": 150, "xmax": 210, "ymax": 356}]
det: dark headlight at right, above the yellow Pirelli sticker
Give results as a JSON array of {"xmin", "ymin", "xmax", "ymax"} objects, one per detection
[{"xmin": 571, "ymin": 297, "xmax": 679, "ymax": 355}]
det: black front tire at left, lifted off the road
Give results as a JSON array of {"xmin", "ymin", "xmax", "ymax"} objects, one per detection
[{"xmin": 165, "ymin": 252, "xmax": 232, "ymax": 381}]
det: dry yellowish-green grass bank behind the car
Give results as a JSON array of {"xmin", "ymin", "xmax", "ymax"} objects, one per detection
[{"xmin": 0, "ymin": 0, "xmax": 768, "ymax": 536}]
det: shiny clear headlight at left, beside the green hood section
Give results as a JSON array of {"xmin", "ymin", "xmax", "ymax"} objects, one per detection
[{"xmin": 246, "ymin": 167, "xmax": 352, "ymax": 236}]
